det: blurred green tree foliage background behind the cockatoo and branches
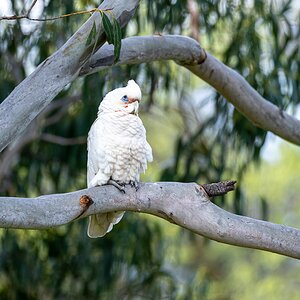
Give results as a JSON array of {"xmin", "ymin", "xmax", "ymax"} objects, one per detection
[{"xmin": 0, "ymin": 0, "xmax": 300, "ymax": 299}]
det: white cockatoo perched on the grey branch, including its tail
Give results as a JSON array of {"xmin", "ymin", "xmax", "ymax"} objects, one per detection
[{"xmin": 87, "ymin": 80, "xmax": 152, "ymax": 238}]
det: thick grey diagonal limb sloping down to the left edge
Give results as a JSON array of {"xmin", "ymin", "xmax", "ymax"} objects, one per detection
[{"xmin": 0, "ymin": 0, "xmax": 139, "ymax": 152}]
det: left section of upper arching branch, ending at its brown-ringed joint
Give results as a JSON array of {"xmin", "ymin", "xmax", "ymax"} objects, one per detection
[{"xmin": 79, "ymin": 35, "xmax": 206, "ymax": 76}]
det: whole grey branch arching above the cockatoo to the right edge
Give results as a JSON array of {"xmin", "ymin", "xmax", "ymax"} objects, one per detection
[{"xmin": 80, "ymin": 35, "xmax": 300, "ymax": 145}]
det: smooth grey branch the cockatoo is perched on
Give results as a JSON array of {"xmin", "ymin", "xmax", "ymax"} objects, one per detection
[{"xmin": 0, "ymin": 182, "xmax": 300, "ymax": 259}]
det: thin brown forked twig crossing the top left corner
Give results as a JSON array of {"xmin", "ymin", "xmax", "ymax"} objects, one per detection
[{"xmin": 0, "ymin": 7, "xmax": 112, "ymax": 22}]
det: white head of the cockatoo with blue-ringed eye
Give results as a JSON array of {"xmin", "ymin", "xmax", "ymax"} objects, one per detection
[{"xmin": 99, "ymin": 80, "xmax": 142, "ymax": 115}]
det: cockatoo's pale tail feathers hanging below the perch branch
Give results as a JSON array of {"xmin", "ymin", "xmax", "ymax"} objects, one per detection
[{"xmin": 88, "ymin": 211, "xmax": 125, "ymax": 238}]
